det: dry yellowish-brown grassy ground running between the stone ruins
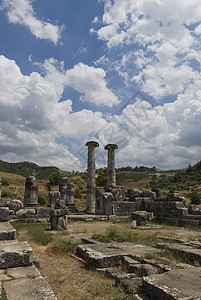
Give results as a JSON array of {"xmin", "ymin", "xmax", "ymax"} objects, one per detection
[{"xmin": 17, "ymin": 221, "xmax": 201, "ymax": 300}]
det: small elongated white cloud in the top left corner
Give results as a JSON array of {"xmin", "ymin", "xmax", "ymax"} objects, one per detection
[{"xmin": 0, "ymin": 0, "xmax": 62, "ymax": 44}]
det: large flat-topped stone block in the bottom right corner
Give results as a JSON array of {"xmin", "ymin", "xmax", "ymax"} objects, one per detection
[{"xmin": 143, "ymin": 268, "xmax": 201, "ymax": 300}]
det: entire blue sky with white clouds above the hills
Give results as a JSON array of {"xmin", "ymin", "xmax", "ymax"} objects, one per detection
[{"xmin": 0, "ymin": 0, "xmax": 201, "ymax": 171}]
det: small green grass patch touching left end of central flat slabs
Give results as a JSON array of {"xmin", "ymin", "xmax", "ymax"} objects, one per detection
[{"xmin": 52, "ymin": 238, "xmax": 81, "ymax": 254}]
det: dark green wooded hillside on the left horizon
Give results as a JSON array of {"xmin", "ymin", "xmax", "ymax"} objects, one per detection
[{"xmin": 0, "ymin": 160, "xmax": 59, "ymax": 179}]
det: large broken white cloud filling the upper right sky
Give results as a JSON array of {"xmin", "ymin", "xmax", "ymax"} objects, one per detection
[{"xmin": 94, "ymin": 0, "xmax": 201, "ymax": 100}]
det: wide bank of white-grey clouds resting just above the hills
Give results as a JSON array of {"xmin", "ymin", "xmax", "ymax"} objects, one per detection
[{"xmin": 0, "ymin": 56, "xmax": 201, "ymax": 170}]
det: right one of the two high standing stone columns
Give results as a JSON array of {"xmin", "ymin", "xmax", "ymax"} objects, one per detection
[{"xmin": 105, "ymin": 144, "xmax": 118, "ymax": 188}]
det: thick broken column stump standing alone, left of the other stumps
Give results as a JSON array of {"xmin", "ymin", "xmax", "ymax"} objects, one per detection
[{"xmin": 24, "ymin": 176, "xmax": 38, "ymax": 207}]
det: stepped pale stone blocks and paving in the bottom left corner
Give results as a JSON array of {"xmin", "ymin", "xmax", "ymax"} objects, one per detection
[{"xmin": 0, "ymin": 222, "xmax": 56, "ymax": 300}]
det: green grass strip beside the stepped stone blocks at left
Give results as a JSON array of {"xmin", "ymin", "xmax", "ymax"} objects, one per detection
[{"xmin": 12, "ymin": 222, "xmax": 53, "ymax": 245}]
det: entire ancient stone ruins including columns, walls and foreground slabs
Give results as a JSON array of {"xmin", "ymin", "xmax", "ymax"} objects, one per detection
[{"xmin": 0, "ymin": 141, "xmax": 201, "ymax": 300}]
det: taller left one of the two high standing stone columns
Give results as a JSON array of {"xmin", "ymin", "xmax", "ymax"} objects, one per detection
[{"xmin": 86, "ymin": 141, "xmax": 99, "ymax": 214}]
